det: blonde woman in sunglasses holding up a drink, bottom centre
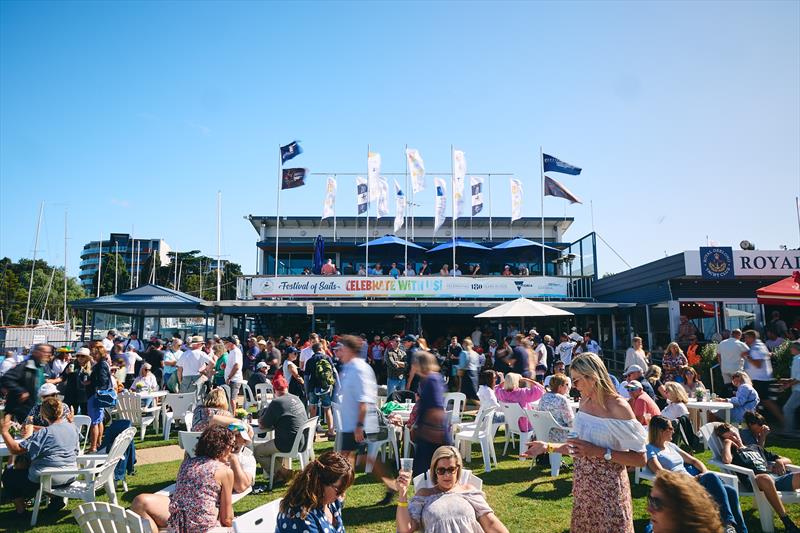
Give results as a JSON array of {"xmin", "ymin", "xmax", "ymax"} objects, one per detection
[{"xmin": 396, "ymin": 446, "xmax": 508, "ymax": 533}]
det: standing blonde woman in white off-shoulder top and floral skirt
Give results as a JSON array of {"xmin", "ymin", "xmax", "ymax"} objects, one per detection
[{"xmin": 526, "ymin": 353, "xmax": 647, "ymax": 533}]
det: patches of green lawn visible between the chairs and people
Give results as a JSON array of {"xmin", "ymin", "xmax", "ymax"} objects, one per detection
[{"xmin": 0, "ymin": 437, "xmax": 800, "ymax": 533}]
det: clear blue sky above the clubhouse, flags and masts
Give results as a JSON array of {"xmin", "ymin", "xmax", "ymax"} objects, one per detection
[{"xmin": 0, "ymin": 1, "xmax": 800, "ymax": 275}]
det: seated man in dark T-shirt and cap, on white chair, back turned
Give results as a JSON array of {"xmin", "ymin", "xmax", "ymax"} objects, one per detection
[{"xmin": 253, "ymin": 375, "xmax": 313, "ymax": 479}]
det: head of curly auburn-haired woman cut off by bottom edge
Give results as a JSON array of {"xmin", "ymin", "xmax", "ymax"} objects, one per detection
[{"xmin": 647, "ymin": 470, "xmax": 725, "ymax": 533}]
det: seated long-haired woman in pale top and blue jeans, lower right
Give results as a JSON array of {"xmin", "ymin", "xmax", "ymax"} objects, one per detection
[{"xmin": 647, "ymin": 416, "xmax": 747, "ymax": 533}]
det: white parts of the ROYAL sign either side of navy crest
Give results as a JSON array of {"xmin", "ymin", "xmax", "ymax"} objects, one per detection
[{"xmin": 683, "ymin": 250, "xmax": 800, "ymax": 277}]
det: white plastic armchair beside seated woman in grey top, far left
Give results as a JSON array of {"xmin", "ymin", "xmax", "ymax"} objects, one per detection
[{"xmin": 31, "ymin": 427, "xmax": 136, "ymax": 526}]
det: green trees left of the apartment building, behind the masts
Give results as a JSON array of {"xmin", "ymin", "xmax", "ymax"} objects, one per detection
[{"xmin": 0, "ymin": 257, "xmax": 86, "ymax": 325}]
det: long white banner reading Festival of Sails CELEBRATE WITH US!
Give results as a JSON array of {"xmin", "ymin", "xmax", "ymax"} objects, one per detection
[{"xmin": 252, "ymin": 276, "xmax": 567, "ymax": 299}]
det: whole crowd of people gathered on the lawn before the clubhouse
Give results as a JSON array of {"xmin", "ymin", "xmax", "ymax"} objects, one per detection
[{"xmin": 0, "ymin": 314, "xmax": 800, "ymax": 533}]
